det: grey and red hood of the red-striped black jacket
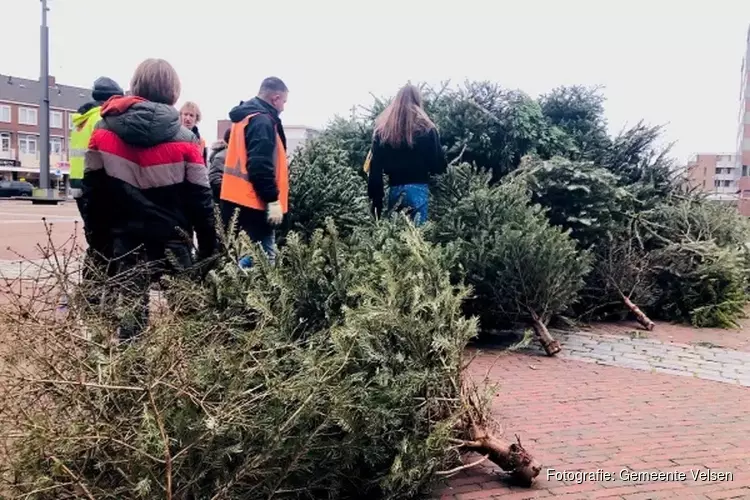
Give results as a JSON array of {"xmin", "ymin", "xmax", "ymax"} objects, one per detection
[{"xmin": 101, "ymin": 96, "xmax": 182, "ymax": 147}]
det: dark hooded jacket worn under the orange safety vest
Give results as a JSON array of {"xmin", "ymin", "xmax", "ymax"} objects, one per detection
[{"xmin": 229, "ymin": 97, "xmax": 286, "ymax": 204}]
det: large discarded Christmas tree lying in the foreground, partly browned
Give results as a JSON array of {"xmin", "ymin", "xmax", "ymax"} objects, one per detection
[{"xmin": 0, "ymin": 220, "xmax": 541, "ymax": 499}]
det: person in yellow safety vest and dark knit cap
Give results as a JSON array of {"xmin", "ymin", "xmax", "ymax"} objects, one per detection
[{"xmin": 68, "ymin": 76, "xmax": 124, "ymax": 302}]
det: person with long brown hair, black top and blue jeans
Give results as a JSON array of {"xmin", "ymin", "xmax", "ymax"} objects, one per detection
[{"xmin": 367, "ymin": 84, "xmax": 447, "ymax": 225}]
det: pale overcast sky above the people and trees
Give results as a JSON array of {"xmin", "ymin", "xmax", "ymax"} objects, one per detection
[{"xmin": 0, "ymin": 0, "xmax": 750, "ymax": 161}]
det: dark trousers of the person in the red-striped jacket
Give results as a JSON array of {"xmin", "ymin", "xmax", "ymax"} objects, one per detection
[{"xmin": 109, "ymin": 238, "xmax": 193, "ymax": 341}]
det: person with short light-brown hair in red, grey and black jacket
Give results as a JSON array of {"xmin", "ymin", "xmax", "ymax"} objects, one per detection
[{"xmin": 82, "ymin": 59, "xmax": 218, "ymax": 340}]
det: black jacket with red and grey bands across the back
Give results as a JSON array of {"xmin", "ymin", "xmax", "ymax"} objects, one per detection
[{"xmin": 82, "ymin": 96, "xmax": 218, "ymax": 257}]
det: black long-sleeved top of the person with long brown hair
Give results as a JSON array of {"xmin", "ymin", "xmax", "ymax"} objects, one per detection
[{"xmin": 367, "ymin": 129, "xmax": 448, "ymax": 211}]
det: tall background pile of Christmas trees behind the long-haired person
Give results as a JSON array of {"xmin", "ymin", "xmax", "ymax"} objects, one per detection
[{"xmin": 288, "ymin": 82, "xmax": 750, "ymax": 354}]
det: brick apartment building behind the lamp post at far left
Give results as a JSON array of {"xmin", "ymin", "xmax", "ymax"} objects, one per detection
[{"xmin": 0, "ymin": 74, "xmax": 91, "ymax": 183}]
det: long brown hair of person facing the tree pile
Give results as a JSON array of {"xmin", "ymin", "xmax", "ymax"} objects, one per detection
[{"xmin": 375, "ymin": 84, "xmax": 435, "ymax": 147}]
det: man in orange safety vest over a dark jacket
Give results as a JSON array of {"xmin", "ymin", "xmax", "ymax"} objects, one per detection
[{"xmin": 219, "ymin": 77, "xmax": 289, "ymax": 268}]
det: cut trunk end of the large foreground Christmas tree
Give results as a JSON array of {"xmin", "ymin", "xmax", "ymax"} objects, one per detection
[{"xmin": 466, "ymin": 427, "xmax": 542, "ymax": 486}]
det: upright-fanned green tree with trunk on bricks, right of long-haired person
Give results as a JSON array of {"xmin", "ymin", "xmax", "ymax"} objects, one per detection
[{"xmin": 428, "ymin": 164, "xmax": 590, "ymax": 355}]
